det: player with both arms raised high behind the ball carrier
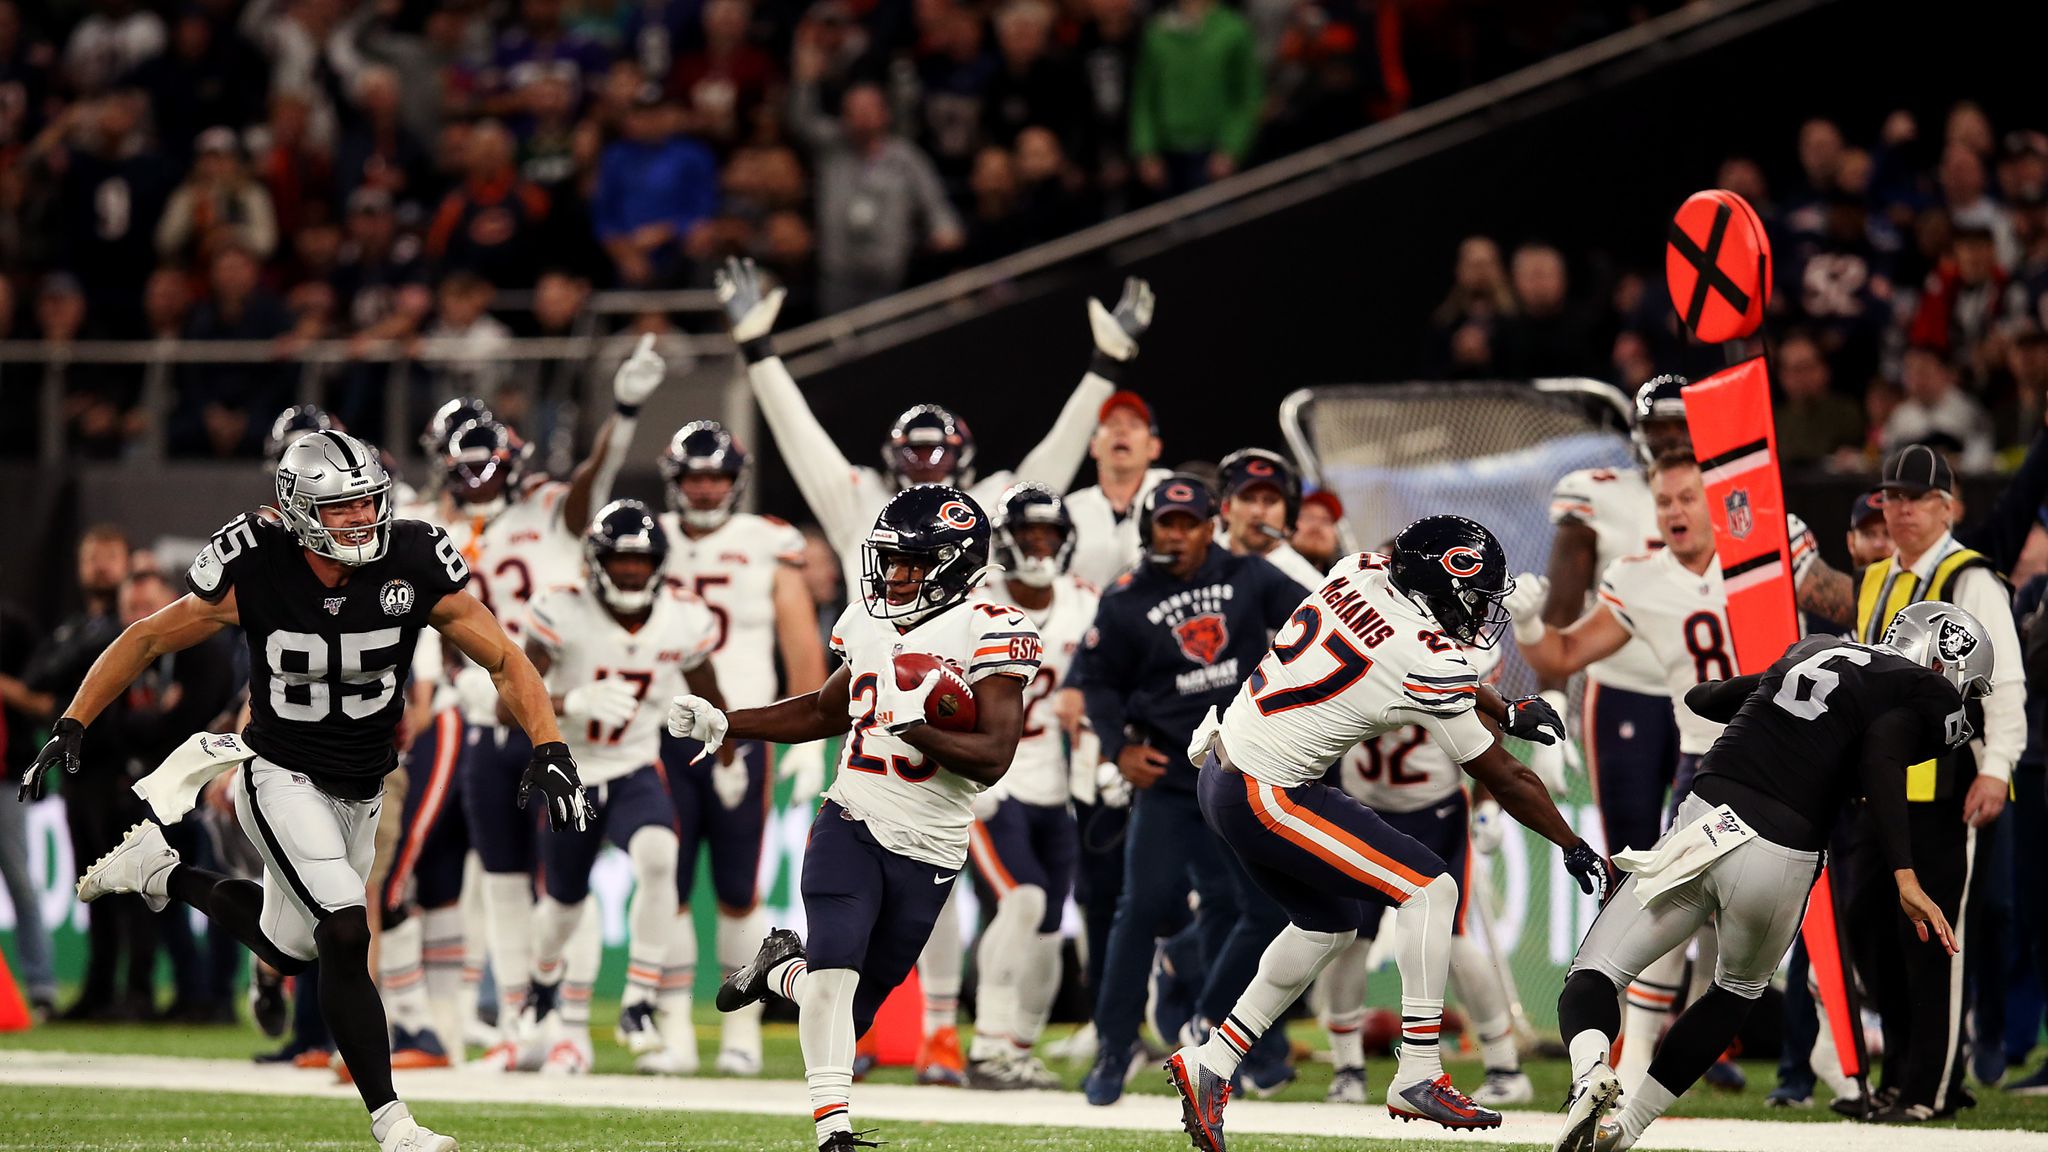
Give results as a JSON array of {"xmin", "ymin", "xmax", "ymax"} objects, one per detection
[{"xmin": 715, "ymin": 249, "xmax": 1153, "ymax": 1084}]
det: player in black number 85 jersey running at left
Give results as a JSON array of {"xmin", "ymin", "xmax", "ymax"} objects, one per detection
[{"xmin": 20, "ymin": 430, "xmax": 590, "ymax": 1152}]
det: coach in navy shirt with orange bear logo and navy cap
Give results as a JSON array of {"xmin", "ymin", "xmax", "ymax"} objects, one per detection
[{"xmin": 1079, "ymin": 474, "xmax": 1309, "ymax": 1105}]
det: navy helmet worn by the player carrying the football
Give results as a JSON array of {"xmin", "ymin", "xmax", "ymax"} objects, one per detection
[{"xmin": 860, "ymin": 484, "xmax": 991, "ymax": 627}]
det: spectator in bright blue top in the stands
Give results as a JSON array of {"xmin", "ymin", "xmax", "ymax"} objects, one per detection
[{"xmin": 592, "ymin": 88, "xmax": 719, "ymax": 287}]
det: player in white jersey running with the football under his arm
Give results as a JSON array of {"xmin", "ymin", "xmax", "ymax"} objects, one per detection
[{"xmin": 668, "ymin": 484, "xmax": 1038, "ymax": 1152}]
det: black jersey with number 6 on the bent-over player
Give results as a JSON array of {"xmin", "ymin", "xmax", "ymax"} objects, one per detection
[{"xmin": 1688, "ymin": 635, "xmax": 1970, "ymax": 851}]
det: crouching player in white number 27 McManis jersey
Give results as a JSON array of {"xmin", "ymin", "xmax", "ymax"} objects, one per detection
[{"xmin": 1167, "ymin": 517, "xmax": 1606, "ymax": 1152}]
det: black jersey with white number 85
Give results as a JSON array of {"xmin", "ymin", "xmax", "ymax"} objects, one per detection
[{"xmin": 184, "ymin": 515, "xmax": 469, "ymax": 787}]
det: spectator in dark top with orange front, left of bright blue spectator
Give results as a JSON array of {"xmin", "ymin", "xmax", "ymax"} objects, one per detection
[{"xmin": 426, "ymin": 121, "xmax": 549, "ymax": 287}]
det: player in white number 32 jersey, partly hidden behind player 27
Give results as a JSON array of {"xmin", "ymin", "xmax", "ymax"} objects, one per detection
[{"xmin": 1323, "ymin": 635, "xmax": 1534, "ymax": 1107}]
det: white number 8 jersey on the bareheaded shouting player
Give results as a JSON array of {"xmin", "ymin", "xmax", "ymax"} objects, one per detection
[{"xmin": 1599, "ymin": 549, "xmax": 1735, "ymax": 756}]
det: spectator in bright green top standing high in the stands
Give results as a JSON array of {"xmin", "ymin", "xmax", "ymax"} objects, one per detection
[{"xmin": 1130, "ymin": 0, "xmax": 1266, "ymax": 195}]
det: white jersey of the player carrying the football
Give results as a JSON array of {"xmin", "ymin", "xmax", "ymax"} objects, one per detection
[{"xmin": 825, "ymin": 601, "xmax": 1040, "ymax": 869}]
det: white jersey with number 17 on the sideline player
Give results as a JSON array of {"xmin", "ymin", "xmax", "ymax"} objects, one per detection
[{"xmin": 526, "ymin": 582, "xmax": 719, "ymax": 785}]
